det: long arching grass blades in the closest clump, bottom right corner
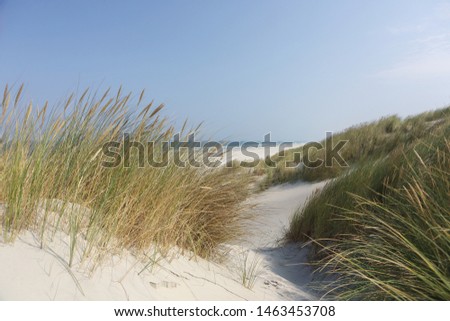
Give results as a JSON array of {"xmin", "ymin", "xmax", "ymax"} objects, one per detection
[{"xmin": 322, "ymin": 139, "xmax": 450, "ymax": 300}]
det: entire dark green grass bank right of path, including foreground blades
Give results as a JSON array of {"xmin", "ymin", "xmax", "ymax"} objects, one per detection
[{"xmin": 286, "ymin": 108, "xmax": 450, "ymax": 300}]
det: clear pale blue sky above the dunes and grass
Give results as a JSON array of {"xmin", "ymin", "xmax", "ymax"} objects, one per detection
[{"xmin": 0, "ymin": 0, "xmax": 450, "ymax": 142}]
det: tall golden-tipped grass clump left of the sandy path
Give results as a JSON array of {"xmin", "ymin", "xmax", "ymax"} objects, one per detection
[{"xmin": 0, "ymin": 87, "xmax": 251, "ymax": 262}]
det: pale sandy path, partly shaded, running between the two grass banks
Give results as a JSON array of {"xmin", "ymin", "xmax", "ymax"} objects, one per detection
[{"xmin": 236, "ymin": 182, "xmax": 325, "ymax": 300}]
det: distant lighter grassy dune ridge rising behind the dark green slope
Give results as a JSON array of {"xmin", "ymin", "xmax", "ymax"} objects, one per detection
[{"xmin": 259, "ymin": 107, "xmax": 450, "ymax": 188}]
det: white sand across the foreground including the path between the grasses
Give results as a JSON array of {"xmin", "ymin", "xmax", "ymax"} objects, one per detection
[{"xmin": 0, "ymin": 170, "xmax": 323, "ymax": 300}]
